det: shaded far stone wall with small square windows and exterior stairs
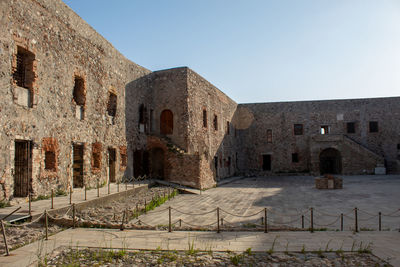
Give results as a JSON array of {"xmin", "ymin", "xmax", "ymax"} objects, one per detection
[{"xmin": 237, "ymin": 97, "xmax": 400, "ymax": 174}]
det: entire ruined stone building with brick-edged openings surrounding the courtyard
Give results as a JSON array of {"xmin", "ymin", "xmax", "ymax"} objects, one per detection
[{"xmin": 0, "ymin": 0, "xmax": 400, "ymax": 200}]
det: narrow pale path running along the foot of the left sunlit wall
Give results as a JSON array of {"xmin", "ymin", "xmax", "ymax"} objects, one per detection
[{"xmin": 0, "ymin": 181, "xmax": 149, "ymax": 220}]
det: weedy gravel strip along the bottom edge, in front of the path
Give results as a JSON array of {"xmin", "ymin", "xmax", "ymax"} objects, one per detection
[{"xmin": 39, "ymin": 248, "xmax": 390, "ymax": 267}]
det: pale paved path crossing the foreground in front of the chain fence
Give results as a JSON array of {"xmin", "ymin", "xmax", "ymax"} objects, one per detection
[{"xmin": 0, "ymin": 228, "xmax": 400, "ymax": 266}]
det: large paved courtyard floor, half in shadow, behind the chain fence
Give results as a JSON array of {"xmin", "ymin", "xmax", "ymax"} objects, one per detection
[{"xmin": 139, "ymin": 175, "xmax": 400, "ymax": 231}]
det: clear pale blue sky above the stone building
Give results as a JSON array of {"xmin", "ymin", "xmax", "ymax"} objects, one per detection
[{"xmin": 64, "ymin": 0, "xmax": 400, "ymax": 103}]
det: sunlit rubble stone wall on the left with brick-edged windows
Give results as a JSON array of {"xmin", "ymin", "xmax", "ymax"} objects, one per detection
[{"xmin": 0, "ymin": 0, "xmax": 150, "ymax": 199}]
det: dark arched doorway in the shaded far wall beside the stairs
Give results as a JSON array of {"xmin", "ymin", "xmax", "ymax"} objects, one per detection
[{"xmin": 319, "ymin": 148, "xmax": 342, "ymax": 174}]
